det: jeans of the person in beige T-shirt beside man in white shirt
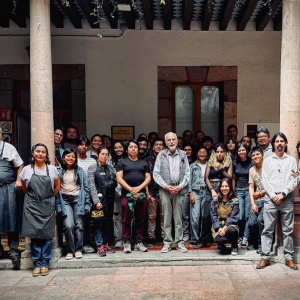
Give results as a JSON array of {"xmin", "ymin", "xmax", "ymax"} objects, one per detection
[{"xmin": 248, "ymin": 200, "xmax": 265, "ymax": 247}]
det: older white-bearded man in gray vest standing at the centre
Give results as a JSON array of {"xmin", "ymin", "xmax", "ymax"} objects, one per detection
[{"xmin": 153, "ymin": 132, "xmax": 190, "ymax": 253}]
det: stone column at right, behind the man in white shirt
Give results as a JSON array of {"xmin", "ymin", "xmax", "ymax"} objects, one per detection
[{"xmin": 277, "ymin": 0, "xmax": 300, "ymax": 263}]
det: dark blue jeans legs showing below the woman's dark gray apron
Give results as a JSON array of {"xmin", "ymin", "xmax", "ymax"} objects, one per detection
[{"xmin": 31, "ymin": 238, "xmax": 51, "ymax": 268}]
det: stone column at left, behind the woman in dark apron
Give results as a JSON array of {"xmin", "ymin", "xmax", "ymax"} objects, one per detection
[{"xmin": 21, "ymin": 0, "xmax": 61, "ymax": 269}]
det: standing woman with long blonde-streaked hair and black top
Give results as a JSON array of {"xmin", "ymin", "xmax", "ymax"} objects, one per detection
[{"xmin": 199, "ymin": 143, "xmax": 232, "ymax": 247}]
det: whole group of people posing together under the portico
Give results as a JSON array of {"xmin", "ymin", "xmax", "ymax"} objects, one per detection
[{"xmin": 0, "ymin": 125, "xmax": 300, "ymax": 276}]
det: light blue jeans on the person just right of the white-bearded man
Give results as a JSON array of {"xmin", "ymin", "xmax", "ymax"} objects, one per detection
[{"xmin": 190, "ymin": 190, "xmax": 206, "ymax": 242}]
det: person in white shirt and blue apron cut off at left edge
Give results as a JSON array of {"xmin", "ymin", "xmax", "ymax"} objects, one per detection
[{"xmin": 0, "ymin": 127, "xmax": 23, "ymax": 269}]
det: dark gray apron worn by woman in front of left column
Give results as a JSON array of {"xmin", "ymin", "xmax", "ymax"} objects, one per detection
[{"xmin": 22, "ymin": 165, "xmax": 55, "ymax": 240}]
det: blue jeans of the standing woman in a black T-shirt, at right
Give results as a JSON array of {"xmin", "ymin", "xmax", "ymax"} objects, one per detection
[{"xmin": 235, "ymin": 186, "xmax": 251, "ymax": 238}]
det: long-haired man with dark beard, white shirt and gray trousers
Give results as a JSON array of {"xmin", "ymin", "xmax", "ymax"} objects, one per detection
[{"xmin": 256, "ymin": 132, "xmax": 298, "ymax": 270}]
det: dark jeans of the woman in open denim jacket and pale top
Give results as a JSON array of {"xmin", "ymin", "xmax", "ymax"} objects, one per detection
[{"xmin": 63, "ymin": 195, "xmax": 84, "ymax": 254}]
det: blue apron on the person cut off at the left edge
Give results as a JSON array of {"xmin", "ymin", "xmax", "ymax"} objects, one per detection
[{"xmin": 0, "ymin": 142, "xmax": 21, "ymax": 234}]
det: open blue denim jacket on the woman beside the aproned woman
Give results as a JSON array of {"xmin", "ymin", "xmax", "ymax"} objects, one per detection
[{"xmin": 55, "ymin": 167, "xmax": 92, "ymax": 216}]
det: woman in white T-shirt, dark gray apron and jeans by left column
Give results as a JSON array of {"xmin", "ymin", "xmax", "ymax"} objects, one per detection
[{"xmin": 20, "ymin": 143, "xmax": 60, "ymax": 276}]
